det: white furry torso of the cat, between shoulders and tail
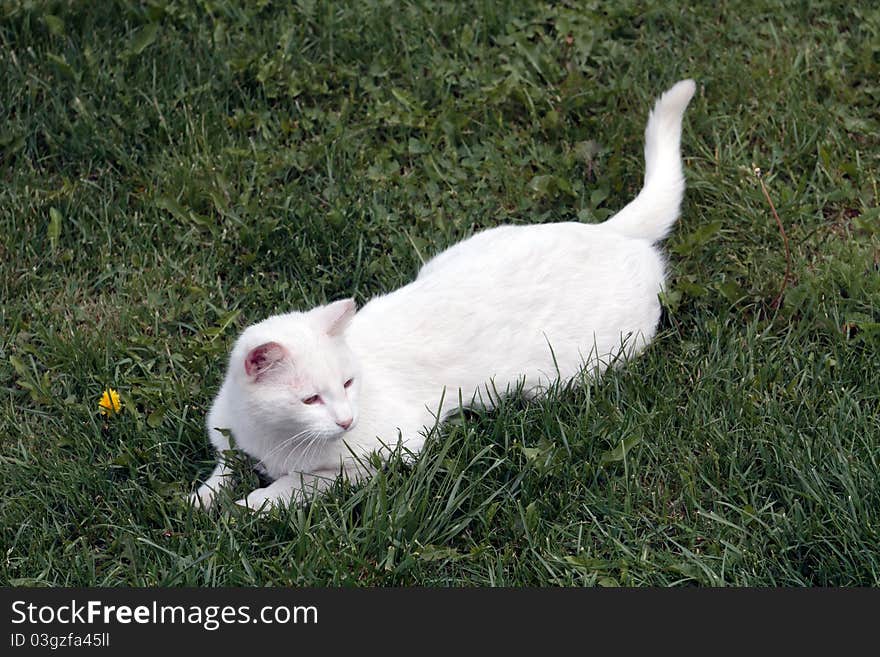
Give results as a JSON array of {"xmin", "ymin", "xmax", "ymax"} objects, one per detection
[{"xmin": 347, "ymin": 223, "xmax": 664, "ymax": 408}]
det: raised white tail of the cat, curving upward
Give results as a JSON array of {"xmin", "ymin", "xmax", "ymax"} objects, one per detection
[{"xmin": 604, "ymin": 80, "xmax": 696, "ymax": 242}]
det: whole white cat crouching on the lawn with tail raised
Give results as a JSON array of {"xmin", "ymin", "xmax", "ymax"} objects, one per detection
[{"xmin": 191, "ymin": 80, "xmax": 695, "ymax": 509}]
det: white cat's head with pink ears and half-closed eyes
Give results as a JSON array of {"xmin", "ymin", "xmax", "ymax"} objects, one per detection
[{"xmin": 228, "ymin": 299, "xmax": 360, "ymax": 439}]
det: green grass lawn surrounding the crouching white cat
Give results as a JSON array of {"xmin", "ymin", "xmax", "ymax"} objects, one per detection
[{"xmin": 0, "ymin": 0, "xmax": 880, "ymax": 586}]
